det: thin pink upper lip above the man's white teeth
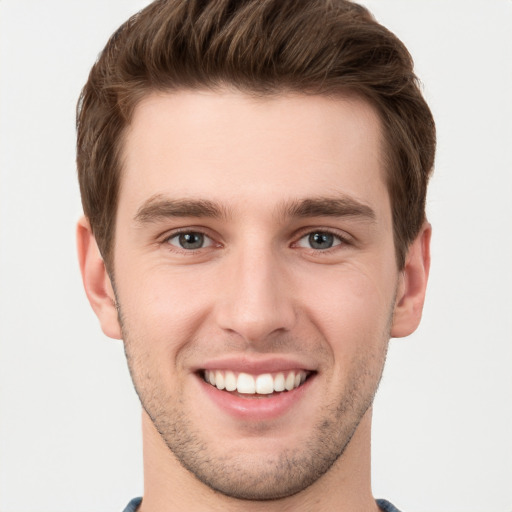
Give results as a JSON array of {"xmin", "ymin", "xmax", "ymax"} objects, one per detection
[{"xmin": 195, "ymin": 355, "xmax": 316, "ymax": 375}]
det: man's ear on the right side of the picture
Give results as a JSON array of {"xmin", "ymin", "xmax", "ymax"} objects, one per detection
[{"xmin": 391, "ymin": 222, "xmax": 432, "ymax": 338}]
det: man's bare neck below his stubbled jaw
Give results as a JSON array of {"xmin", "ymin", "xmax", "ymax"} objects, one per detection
[{"xmin": 140, "ymin": 409, "xmax": 379, "ymax": 512}]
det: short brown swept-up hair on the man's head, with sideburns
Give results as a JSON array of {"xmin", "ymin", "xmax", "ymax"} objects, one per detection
[{"xmin": 77, "ymin": 0, "xmax": 436, "ymax": 268}]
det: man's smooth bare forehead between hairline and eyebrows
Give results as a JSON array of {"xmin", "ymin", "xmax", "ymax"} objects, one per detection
[{"xmin": 120, "ymin": 90, "xmax": 389, "ymax": 220}]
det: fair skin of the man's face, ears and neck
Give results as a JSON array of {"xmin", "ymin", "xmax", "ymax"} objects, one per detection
[{"xmin": 78, "ymin": 90, "xmax": 430, "ymax": 512}]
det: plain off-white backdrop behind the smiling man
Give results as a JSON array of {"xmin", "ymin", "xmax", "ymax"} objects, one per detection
[{"xmin": 0, "ymin": 0, "xmax": 512, "ymax": 512}]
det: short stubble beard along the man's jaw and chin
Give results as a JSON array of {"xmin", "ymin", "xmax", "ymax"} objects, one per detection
[{"xmin": 118, "ymin": 303, "xmax": 392, "ymax": 501}]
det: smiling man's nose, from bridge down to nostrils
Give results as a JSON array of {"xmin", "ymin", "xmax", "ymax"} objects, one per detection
[{"xmin": 216, "ymin": 248, "xmax": 296, "ymax": 344}]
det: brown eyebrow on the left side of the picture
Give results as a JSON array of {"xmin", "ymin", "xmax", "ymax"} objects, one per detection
[{"xmin": 135, "ymin": 194, "xmax": 228, "ymax": 224}]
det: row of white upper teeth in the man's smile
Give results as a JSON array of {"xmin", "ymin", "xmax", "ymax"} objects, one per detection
[{"xmin": 204, "ymin": 370, "xmax": 307, "ymax": 395}]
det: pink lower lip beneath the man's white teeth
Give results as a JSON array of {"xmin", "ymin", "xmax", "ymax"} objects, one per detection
[{"xmin": 197, "ymin": 375, "xmax": 314, "ymax": 421}]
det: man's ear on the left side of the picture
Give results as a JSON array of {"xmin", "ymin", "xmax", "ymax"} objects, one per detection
[{"xmin": 76, "ymin": 217, "xmax": 122, "ymax": 339}]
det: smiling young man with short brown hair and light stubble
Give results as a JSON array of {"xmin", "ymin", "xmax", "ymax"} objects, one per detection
[{"xmin": 77, "ymin": 0, "xmax": 435, "ymax": 512}]
